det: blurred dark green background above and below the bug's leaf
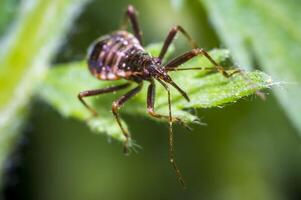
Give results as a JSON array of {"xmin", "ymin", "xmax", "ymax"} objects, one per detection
[{"xmin": 0, "ymin": 0, "xmax": 301, "ymax": 200}]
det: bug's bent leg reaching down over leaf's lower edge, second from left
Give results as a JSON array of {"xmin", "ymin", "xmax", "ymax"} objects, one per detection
[{"xmin": 112, "ymin": 82, "xmax": 143, "ymax": 153}]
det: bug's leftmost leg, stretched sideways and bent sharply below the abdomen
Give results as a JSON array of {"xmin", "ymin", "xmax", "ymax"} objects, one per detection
[{"xmin": 77, "ymin": 83, "xmax": 130, "ymax": 116}]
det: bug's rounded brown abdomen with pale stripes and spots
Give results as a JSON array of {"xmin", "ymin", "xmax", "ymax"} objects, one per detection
[{"xmin": 88, "ymin": 31, "xmax": 151, "ymax": 80}]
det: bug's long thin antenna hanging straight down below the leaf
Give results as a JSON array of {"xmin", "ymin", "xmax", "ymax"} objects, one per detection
[{"xmin": 157, "ymin": 79, "xmax": 186, "ymax": 188}]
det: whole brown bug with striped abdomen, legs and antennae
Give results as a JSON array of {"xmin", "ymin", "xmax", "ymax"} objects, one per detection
[{"xmin": 78, "ymin": 5, "xmax": 238, "ymax": 186}]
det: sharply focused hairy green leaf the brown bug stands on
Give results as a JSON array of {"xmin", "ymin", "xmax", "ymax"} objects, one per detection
[{"xmin": 40, "ymin": 44, "xmax": 272, "ymax": 143}]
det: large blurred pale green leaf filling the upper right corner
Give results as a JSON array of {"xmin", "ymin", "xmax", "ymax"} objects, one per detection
[{"xmin": 200, "ymin": 0, "xmax": 301, "ymax": 133}]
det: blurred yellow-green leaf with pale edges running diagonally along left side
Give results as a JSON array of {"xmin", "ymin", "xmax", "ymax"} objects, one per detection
[{"xmin": 0, "ymin": 0, "xmax": 89, "ymax": 186}]
